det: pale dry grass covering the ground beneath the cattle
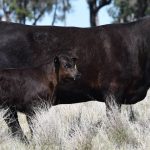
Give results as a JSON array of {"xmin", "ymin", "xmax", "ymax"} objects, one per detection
[{"xmin": 0, "ymin": 91, "xmax": 150, "ymax": 150}]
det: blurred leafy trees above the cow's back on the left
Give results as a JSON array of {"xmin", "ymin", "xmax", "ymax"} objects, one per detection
[{"xmin": 0, "ymin": 0, "xmax": 71, "ymax": 25}]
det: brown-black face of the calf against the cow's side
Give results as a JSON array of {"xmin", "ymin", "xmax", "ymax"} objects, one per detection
[{"xmin": 54, "ymin": 55, "xmax": 81, "ymax": 80}]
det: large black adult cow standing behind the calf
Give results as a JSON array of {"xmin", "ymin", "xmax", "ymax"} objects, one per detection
[{"xmin": 0, "ymin": 17, "xmax": 150, "ymax": 139}]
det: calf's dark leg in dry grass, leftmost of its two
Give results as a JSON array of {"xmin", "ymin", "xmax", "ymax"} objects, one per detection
[{"xmin": 4, "ymin": 106, "xmax": 28, "ymax": 142}]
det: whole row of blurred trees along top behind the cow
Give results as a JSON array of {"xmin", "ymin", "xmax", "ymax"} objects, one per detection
[{"xmin": 0, "ymin": 0, "xmax": 150, "ymax": 26}]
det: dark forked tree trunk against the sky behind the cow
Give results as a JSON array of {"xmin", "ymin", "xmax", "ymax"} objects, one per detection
[{"xmin": 87, "ymin": 0, "xmax": 111, "ymax": 26}]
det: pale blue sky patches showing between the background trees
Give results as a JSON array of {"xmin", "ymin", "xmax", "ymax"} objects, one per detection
[{"xmin": 37, "ymin": 0, "xmax": 113, "ymax": 27}]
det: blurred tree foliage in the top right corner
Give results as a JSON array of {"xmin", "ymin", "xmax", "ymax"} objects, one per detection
[{"xmin": 109, "ymin": 0, "xmax": 150, "ymax": 23}]
